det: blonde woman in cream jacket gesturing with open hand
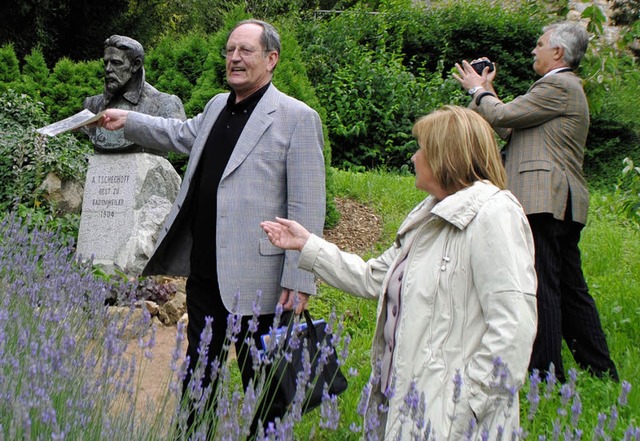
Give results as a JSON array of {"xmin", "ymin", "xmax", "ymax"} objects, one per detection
[{"xmin": 261, "ymin": 106, "xmax": 536, "ymax": 440}]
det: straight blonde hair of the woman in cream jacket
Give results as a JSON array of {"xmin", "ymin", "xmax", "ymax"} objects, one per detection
[{"xmin": 412, "ymin": 106, "xmax": 507, "ymax": 194}]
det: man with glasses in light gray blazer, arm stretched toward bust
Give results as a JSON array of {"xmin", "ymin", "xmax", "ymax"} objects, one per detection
[{"xmin": 98, "ymin": 20, "xmax": 325, "ymax": 428}]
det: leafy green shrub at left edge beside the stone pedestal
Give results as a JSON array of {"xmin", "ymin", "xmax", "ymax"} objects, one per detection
[{"xmin": 0, "ymin": 90, "xmax": 90, "ymax": 214}]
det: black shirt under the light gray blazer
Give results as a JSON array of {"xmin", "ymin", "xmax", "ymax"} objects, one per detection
[{"xmin": 191, "ymin": 83, "xmax": 271, "ymax": 280}]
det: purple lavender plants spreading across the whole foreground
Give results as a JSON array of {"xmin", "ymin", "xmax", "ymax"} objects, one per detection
[{"xmin": 6, "ymin": 211, "xmax": 640, "ymax": 441}]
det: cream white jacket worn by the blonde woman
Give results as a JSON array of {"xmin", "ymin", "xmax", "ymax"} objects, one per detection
[{"xmin": 299, "ymin": 181, "xmax": 537, "ymax": 440}]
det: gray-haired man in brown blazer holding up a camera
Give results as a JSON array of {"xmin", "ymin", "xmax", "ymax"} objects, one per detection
[{"xmin": 454, "ymin": 22, "xmax": 618, "ymax": 382}]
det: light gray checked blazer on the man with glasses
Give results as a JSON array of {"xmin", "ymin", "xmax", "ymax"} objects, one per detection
[{"xmin": 124, "ymin": 85, "xmax": 326, "ymax": 315}]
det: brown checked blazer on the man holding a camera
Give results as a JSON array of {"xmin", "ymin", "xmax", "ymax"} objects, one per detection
[{"xmin": 469, "ymin": 71, "xmax": 589, "ymax": 224}]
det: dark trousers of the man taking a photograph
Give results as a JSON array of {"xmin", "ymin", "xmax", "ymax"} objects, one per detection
[{"xmin": 527, "ymin": 213, "xmax": 618, "ymax": 382}]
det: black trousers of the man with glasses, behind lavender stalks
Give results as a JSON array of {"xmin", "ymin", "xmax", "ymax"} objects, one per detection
[{"xmin": 182, "ymin": 277, "xmax": 283, "ymax": 435}]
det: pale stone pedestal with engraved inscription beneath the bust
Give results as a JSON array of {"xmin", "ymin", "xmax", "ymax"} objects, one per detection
[{"xmin": 77, "ymin": 153, "xmax": 181, "ymax": 275}]
